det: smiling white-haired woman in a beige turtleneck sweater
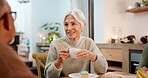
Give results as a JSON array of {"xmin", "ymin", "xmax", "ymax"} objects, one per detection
[{"xmin": 45, "ymin": 9, "xmax": 108, "ymax": 78}]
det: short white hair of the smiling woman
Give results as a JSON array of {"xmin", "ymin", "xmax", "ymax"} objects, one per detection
[{"xmin": 64, "ymin": 9, "xmax": 86, "ymax": 28}]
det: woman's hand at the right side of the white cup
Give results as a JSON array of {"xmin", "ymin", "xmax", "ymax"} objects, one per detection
[{"xmin": 75, "ymin": 49, "xmax": 97, "ymax": 61}]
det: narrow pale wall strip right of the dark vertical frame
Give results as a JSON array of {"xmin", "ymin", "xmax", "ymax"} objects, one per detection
[{"xmin": 94, "ymin": 0, "xmax": 104, "ymax": 43}]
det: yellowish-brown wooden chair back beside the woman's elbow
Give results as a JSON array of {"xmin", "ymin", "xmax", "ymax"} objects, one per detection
[{"xmin": 32, "ymin": 53, "xmax": 48, "ymax": 78}]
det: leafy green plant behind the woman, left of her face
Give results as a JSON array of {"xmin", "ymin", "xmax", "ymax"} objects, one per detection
[{"xmin": 40, "ymin": 22, "xmax": 62, "ymax": 43}]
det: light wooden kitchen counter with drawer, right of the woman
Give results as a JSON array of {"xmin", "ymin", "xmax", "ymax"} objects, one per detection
[{"xmin": 96, "ymin": 43, "xmax": 146, "ymax": 72}]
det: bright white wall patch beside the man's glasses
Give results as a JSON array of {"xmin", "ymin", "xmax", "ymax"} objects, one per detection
[{"xmin": 7, "ymin": 0, "xmax": 32, "ymax": 32}]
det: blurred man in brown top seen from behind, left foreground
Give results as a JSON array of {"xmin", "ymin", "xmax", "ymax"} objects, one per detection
[{"xmin": 0, "ymin": 0, "xmax": 36, "ymax": 78}]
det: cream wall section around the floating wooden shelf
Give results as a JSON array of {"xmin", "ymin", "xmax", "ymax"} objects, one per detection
[{"xmin": 125, "ymin": 0, "xmax": 148, "ymax": 43}]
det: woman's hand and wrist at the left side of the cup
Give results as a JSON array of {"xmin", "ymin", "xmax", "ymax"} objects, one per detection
[{"xmin": 55, "ymin": 48, "xmax": 70, "ymax": 69}]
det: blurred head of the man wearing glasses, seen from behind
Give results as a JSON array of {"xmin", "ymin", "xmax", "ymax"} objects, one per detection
[{"xmin": 0, "ymin": 0, "xmax": 15, "ymax": 43}]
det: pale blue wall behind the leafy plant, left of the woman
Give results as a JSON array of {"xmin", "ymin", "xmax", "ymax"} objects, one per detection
[{"xmin": 30, "ymin": 0, "xmax": 70, "ymax": 52}]
